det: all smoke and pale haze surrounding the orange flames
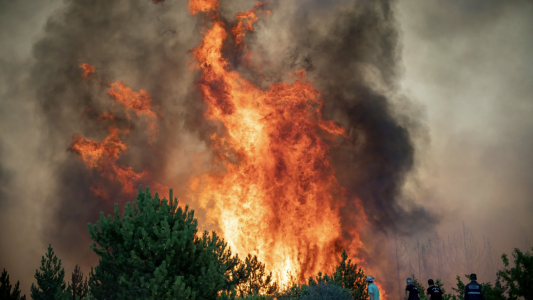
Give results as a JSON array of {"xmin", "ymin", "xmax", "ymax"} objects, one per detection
[{"xmin": 0, "ymin": 0, "xmax": 533, "ymax": 294}]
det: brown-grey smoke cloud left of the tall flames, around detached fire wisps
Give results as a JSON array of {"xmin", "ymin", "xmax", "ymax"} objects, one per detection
[{"xmin": 22, "ymin": 1, "xmax": 211, "ymax": 282}]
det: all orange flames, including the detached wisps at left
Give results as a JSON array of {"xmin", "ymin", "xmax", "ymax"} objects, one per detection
[{"xmin": 69, "ymin": 0, "xmax": 370, "ymax": 290}]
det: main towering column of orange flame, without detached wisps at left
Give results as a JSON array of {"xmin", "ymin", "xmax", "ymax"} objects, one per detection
[{"xmin": 185, "ymin": 0, "xmax": 360, "ymax": 285}]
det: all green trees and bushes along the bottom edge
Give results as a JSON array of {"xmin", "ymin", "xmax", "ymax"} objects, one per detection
[{"xmin": 8, "ymin": 188, "xmax": 533, "ymax": 300}]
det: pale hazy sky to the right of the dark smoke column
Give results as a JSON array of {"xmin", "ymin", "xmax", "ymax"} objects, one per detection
[{"xmin": 398, "ymin": 1, "xmax": 533, "ymax": 251}]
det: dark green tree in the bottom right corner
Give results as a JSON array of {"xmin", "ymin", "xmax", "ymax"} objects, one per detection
[{"xmin": 498, "ymin": 249, "xmax": 533, "ymax": 300}]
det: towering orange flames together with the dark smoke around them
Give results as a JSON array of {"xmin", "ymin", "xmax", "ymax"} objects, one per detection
[{"xmin": 1, "ymin": 0, "xmax": 448, "ymax": 298}]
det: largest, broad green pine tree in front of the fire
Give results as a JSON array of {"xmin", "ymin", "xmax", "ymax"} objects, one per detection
[{"xmin": 89, "ymin": 188, "xmax": 246, "ymax": 300}]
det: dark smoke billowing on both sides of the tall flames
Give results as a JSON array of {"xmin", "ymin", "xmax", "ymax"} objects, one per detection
[{"xmin": 2, "ymin": 0, "xmax": 429, "ymax": 294}]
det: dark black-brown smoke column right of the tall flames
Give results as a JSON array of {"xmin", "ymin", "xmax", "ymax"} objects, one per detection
[{"xmin": 249, "ymin": 1, "xmax": 432, "ymax": 291}]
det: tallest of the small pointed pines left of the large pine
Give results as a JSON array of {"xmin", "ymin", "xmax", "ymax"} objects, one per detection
[{"xmin": 31, "ymin": 245, "xmax": 70, "ymax": 300}]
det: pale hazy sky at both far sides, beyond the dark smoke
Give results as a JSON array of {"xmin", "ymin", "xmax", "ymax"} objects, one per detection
[{"xmin": 0, "ymin": 0, "xmax": 533, "ymax": 293}]
